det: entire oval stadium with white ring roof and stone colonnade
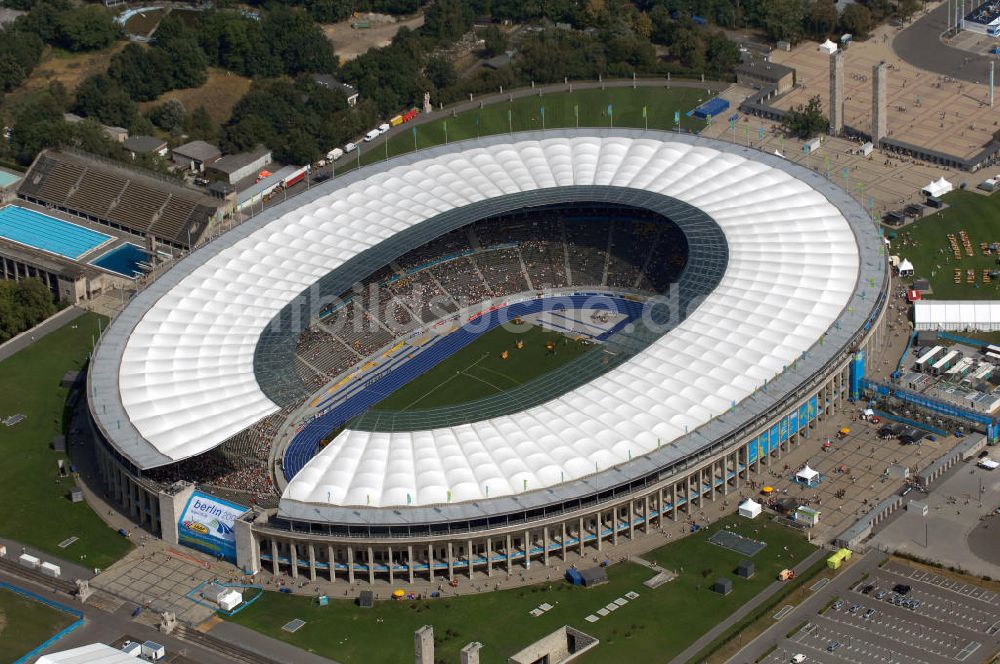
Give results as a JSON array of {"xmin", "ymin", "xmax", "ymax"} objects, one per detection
[{"xmin": 82, "ymin": 129, "xmax": 889, "ymax": 583}]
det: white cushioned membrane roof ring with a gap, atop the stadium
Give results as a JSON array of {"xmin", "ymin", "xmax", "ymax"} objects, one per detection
[{"xmin": 95, "ymin": 134, "xmax": 859, "ymax": 507}]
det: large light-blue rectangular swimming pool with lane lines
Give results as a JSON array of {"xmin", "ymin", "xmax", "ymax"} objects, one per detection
[{"xmin": 0, "ymin": 205, "xmax": 111, "ymax": 258}]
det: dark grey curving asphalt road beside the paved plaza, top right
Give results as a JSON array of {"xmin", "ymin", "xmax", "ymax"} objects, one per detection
[{"xmin": 892, "ymin": 3, "xmax": 990, "ymax": 83}]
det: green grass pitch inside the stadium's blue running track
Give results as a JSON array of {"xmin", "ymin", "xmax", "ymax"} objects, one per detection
[{"xmin": 373, "ymin": 326, "xmax": 596, "ymax": 411}]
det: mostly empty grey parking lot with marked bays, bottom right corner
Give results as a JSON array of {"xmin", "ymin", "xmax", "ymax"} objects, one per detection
[{"xmin": 761, "ymin": 563, "xmax": 1000, "ymax": 664}]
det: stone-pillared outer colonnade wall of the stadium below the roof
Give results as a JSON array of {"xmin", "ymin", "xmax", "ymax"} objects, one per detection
[{"xmin": 82, "ymin": 132, "xmax": 890, "ymax": 585}]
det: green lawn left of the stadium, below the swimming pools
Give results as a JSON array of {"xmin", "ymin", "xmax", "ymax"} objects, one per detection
[{"xmin": 0, "ymin": 314, "xmax": 131, "ymax": 567}]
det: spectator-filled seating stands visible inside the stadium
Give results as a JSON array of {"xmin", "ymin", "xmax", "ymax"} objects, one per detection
[{"xmin": 149, "ymin": 211, "xmax": 687, "ymax": 498}]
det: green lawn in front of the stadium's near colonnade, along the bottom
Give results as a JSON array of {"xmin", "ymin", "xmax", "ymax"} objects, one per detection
[{"xmin": 230, "ymin": 517, "xmax": 815, "ymax": 664}]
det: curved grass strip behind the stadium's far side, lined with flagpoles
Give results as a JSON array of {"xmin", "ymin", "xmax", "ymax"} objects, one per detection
[{"xmin": 337, "ymin": 87, "xmax": 712, "ymax": 173}]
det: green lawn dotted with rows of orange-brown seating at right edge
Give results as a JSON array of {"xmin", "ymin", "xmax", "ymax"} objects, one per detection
[{"xmin": 887, "ymin": 191, "xmax": 1000, "ymax": 300}]
